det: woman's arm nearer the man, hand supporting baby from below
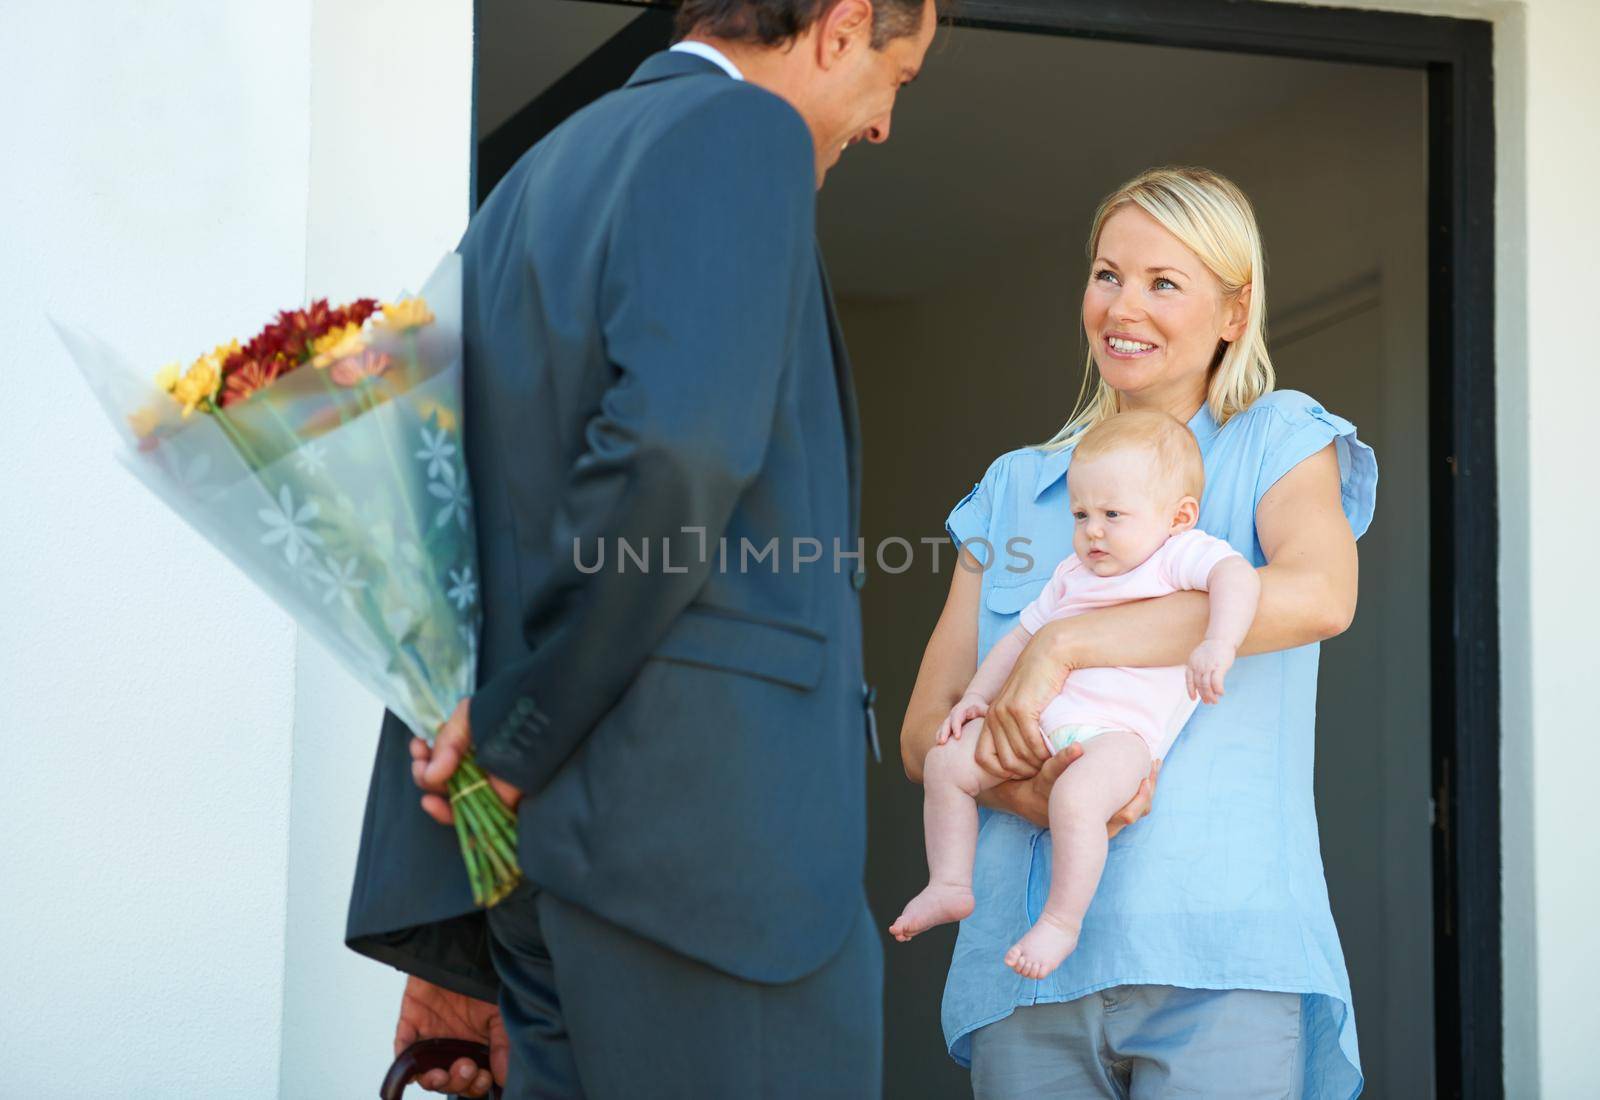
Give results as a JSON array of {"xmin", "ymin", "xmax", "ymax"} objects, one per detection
[{"xmin": 901, "ymin": 550, "xmax": 1160, "ymax": 836}]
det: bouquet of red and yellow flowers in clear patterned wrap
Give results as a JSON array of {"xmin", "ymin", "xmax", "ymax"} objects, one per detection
[{"xmin": 56, "ymin": 253, "xmax": 520, "ymax": 907}]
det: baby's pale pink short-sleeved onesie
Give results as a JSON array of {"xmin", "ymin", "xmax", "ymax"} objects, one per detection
[{"xmin": 1021, "ymin": 528, "xmax": 1243, "ymax": 759}]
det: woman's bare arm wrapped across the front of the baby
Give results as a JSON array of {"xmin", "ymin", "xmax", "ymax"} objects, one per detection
[{"xmin": 986, "ymin": 443, "xmax": 1357, "ymax": 769}]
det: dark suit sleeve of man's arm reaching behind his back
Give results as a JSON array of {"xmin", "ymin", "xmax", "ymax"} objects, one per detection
[{"xmin": 470, "ymin": 85, "xmax": 819, "ymax": 793}]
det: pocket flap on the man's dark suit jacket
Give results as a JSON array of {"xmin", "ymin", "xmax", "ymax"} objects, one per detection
[{"xmin": 650, "ymin": 608, "xmax": 827, "ymax": 691}]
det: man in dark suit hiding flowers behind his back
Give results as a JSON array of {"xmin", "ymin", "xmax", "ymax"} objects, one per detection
[{"xmin": 347, "ymin": 0, "xmax": 936, "ymax": 1100}]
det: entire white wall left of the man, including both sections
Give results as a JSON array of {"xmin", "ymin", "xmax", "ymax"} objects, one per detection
[{"xmin": 0, "ymin": 0, "xmax": 472, "ymax": 1097}]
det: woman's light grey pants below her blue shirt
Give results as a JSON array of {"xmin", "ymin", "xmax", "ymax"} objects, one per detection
[{"xmin": 973, "ymin": 985, "xmax": 1306, "ymax": 1100}]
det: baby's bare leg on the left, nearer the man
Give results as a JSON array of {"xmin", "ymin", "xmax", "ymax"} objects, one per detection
[{"xmin": 890, "ymin": 726, "xmax": 1005, "ymax": 943}]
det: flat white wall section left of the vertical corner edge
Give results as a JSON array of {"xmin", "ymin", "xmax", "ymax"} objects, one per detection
[{"xmin": 0, "ymin": 0, "xmax": 310, "ymax": 1098}]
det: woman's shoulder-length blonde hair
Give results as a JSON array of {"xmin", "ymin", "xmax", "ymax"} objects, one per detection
[{"xmin": 1038, "ymin": 168, "xmax": 1275, "ymax": 451}]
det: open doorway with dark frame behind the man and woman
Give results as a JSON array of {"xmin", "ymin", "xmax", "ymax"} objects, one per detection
[{"xmin": 475, "ymin": 0, "xmax": 1501, "ymax": 1097}]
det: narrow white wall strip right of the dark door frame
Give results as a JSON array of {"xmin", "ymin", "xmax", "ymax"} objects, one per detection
[{"xmin": 1496, "ymin": 0, "xmax": 1600, "ymax": 1098}]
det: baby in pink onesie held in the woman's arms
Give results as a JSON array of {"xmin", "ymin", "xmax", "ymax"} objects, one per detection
[{"xmin": 890, "ymin": 411, "xmax": 1261, "ymax": 978}]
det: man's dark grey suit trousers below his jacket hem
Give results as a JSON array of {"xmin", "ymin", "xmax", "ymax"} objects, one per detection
[{"xmin": 490, "ymin": 884, "xmax": 883, "ymax": 1100}]
